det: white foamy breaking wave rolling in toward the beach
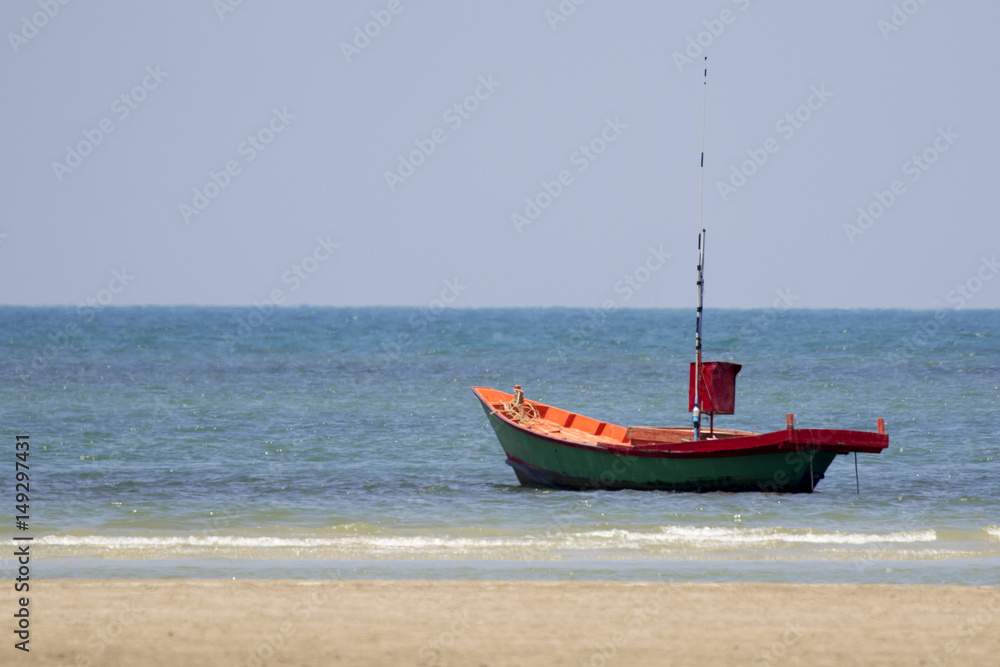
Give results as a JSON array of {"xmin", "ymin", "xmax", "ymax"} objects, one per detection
[{"xmin": 36, "ymin": 526, "xmax": 960, "ymax": 559}]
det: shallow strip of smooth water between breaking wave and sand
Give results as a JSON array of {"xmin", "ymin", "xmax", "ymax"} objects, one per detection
[{"xmin": 29, "ymin": 553, "xmax": 1000, "ymax": 586}]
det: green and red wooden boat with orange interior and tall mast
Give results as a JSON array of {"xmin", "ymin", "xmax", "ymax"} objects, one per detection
[{"xmin": 473, "ymin": 58, "xmax": 889, "ymax": 492}]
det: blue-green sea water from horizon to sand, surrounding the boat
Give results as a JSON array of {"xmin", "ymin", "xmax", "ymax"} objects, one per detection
[{"xmin": 0, "ymin": 307, "xmax": 1000, "ymax": 585}]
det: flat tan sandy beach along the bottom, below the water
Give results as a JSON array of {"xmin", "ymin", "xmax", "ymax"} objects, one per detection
[{"xmin": 15, "ymin": 579, "xmax": 1000, "ymax": 666}]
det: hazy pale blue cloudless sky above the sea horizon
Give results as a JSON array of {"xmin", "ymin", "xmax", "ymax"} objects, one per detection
[{"xmin": 0, "ymin": 0, "xmax": 1000, "ymax": 308}]
